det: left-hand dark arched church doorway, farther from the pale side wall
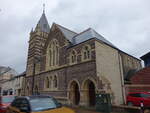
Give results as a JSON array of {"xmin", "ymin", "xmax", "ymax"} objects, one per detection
[{"xmin": 69, "ymin": 81, "xmax": 80, "ymax": 105}]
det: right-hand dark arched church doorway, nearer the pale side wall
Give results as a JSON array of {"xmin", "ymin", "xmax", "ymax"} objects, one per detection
[{"xmin": 82, "ymin": 79, "xmax": 96, "ymax": 106}]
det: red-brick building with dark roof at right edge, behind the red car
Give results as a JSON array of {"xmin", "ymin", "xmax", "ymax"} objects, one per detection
[{"xmin": 126, "ymin": 52, "xmax": 150, "ymax": 96}]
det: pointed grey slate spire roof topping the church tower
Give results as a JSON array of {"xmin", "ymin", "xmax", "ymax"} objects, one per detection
[{"xmin": 36, "ymin": 12, "xmax": 50, "ymax": 33}]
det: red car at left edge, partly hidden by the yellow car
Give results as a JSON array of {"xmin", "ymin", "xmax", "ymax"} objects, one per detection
[{"xmin": 0, "ymin": 96, "xmax": 15, "ymax": 113}]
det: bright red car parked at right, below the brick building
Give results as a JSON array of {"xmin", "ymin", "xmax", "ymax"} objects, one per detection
[{"xmin": 127, "ymin": 92, "xmax": 150, "ymax": 107}]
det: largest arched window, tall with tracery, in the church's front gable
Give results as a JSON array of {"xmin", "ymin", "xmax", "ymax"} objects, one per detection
[{"xmin": 47, "ymin": 40, "xmax": 59, "ymax": 67}]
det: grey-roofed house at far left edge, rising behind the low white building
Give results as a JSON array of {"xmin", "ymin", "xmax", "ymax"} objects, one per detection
[{"xmin": 0, "ymin": 66, "xmax": 17, "ymax": 94}]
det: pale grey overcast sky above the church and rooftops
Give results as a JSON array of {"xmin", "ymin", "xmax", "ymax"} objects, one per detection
[{"xmin": 0, "ymin": 0, "xmax": 150, "ymax": 73}]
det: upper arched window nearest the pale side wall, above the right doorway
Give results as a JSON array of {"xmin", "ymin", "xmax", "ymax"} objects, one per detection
[{"xmin": 82, "ymin": 45, "xmax": 91, "ymax": 60}]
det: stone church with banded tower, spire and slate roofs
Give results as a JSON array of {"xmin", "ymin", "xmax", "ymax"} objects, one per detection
[{"xmin": 23, "ymin": 11, "xmax": 141, "ymax": 106}]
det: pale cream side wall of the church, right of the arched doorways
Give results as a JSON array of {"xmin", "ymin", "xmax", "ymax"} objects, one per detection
[{"xmin": 95, "ymin": 41, "xmax": 123, "ymax": 104}]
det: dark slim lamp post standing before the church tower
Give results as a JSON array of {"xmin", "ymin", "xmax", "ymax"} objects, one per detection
[{"xmin": 32, "ymin": 57, "xmax": 40, "ymax": 95}]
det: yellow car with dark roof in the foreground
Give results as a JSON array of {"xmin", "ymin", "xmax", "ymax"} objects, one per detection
[{"xmin": 7, "ymin": 96, "xmax": 75, "ymax": 113}]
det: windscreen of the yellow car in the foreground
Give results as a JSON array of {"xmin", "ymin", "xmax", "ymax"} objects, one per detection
[{"xmin": 30, "ymin": 98, "xmax": 57, "ymax": 111}]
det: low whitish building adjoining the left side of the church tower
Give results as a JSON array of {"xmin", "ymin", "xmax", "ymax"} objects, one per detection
[{"xmin": 2, "ymin": 72, "xmax": 26, "ymax": 96}]
